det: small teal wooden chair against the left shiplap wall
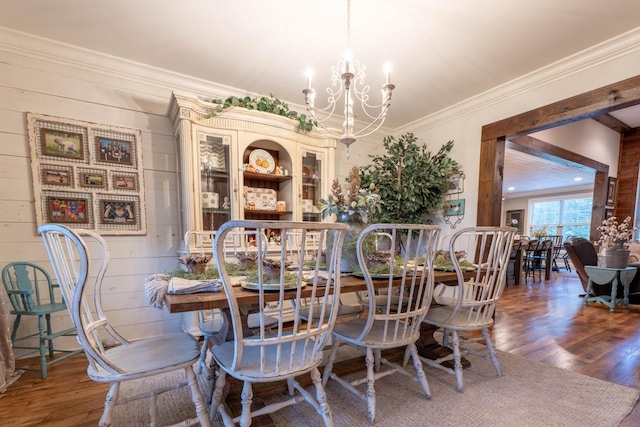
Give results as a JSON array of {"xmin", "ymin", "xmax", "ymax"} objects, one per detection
[{"xmin": 2, "ymin": 262, "xmax": 82, "ymax": 379}]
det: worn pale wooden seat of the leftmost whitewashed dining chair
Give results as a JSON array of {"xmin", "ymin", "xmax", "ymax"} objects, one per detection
[{"xmin": 87, "ymin": 332, "xmax": 200, "ymax": 382}]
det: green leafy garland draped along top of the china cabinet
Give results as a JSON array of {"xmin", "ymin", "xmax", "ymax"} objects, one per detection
[{"xmin": 207, "ymin": 94, "xmax": 317, "ymax": 132}]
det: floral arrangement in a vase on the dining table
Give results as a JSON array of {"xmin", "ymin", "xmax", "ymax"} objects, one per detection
[{"xmin": 320, "ymin": 166, "xmax": 382, "ymax": 273}]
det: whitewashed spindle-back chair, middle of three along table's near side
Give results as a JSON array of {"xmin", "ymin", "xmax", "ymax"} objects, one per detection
[{"xmin": 322, "ymin": 224, "xmax": 440, "ymax": 425}]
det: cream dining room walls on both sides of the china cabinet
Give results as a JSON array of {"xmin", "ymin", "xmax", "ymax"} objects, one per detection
[{"xmin": 0, "ymin": 28, "xmax": 640, "ymax": 348}]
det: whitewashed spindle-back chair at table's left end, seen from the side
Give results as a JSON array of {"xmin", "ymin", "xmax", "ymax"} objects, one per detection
[{"xmin": 38, "ymin": 224, "xmax": 211, "ymax": 426}]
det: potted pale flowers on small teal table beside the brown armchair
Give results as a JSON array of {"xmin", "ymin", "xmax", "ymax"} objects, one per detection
[{"xmin": 598, "ymin": 216, "xmax": 636, "ymax": 268}]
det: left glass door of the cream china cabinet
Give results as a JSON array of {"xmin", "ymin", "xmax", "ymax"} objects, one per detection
[{"xmin": 199, "ymin": 135, "xmax": 231, "ymax": 230}]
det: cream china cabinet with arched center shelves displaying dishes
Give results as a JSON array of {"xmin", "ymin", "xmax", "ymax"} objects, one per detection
[{"xmin": 170, "ymin": 92, "xmax": 336, "ymax": 249}]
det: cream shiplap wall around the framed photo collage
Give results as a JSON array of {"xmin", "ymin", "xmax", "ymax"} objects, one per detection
[{"xmin": 0, "ymin": 40, "xmax": 192, "ymax": 354}]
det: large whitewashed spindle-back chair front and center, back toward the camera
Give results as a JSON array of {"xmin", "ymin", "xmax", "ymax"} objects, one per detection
[{"xmin": 210, "ymin": 220, "xmax": 346, "ymax": 426}]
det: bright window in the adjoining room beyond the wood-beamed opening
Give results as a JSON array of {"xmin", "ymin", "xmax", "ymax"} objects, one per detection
[{"xmin": 528, "ymin": 194, "xmax": 593, "ymax": 240}]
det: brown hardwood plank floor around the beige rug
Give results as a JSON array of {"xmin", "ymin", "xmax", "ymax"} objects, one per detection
[{"xmin": 0, "ymin": 273, "xmax": 640, "ymax": 427}]
